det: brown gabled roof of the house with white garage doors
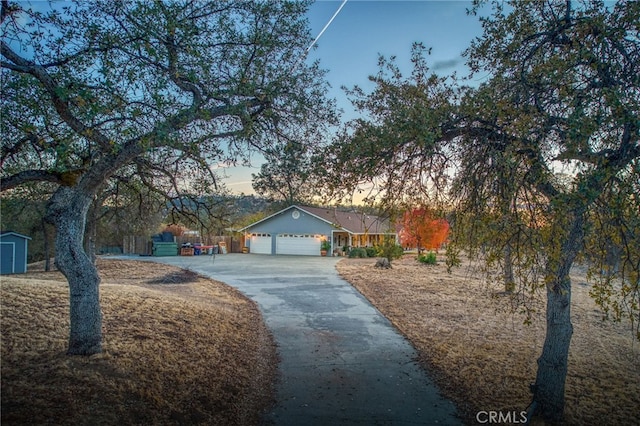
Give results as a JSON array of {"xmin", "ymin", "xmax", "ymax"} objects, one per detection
[{"xmin": 239, "ymin": 205, "xmax": 393, "ymax": 234}]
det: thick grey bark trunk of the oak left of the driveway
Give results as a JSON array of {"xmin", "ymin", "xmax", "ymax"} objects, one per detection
[{"xmin": 47, "ymin": 187, "xmax": 102, "ymax": 355}]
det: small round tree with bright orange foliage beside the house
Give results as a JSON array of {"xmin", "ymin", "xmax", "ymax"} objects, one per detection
[{"xmin": 400, "ymin": 207, "xmax": 449, "ymax": 253}]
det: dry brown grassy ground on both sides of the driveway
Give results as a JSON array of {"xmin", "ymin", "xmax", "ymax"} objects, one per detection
[{"xmin": 0, "ymin": 256, "xmax": 640, "ymax": 425}]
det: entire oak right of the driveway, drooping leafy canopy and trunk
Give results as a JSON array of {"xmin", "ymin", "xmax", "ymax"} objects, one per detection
[{"xmin": 330, "ymin": 0, "xmax": 640, "ymax": 421}]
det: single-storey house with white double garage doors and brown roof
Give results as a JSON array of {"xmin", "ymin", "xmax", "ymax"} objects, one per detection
[{"xmin": 239, "ymin": 206, "xmax": 397, "ymax": 256}]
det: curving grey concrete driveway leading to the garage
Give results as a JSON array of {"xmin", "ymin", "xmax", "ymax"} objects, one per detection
[{"xmin": 130, "ymin": 254, "xmax": 462, "ymax": 426}]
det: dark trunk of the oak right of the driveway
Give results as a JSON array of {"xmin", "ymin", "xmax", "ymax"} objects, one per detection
[{"xmin": 533, "ymin": 212, "xmax": 584, "ymax": 424}]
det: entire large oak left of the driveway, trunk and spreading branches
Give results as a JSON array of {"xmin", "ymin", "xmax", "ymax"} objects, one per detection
[{"xmin": 0, "ymin": 0, "xmax": 334, "ymax": 354}]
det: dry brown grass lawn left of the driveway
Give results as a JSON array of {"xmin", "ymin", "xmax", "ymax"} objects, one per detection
[{"xmin": 1, "ymin": 260, "xmax": 277, "ymax": 425}]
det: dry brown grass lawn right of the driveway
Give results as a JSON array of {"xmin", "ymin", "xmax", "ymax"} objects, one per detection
[{"xmin": 337, "ymin": 255, "xmax": 640, "ymax": 426}]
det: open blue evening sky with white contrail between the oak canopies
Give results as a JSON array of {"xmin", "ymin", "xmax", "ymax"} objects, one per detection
[{"xmin": 225, "ymin": 0, "xmax": 482, "ymax": 194}]
